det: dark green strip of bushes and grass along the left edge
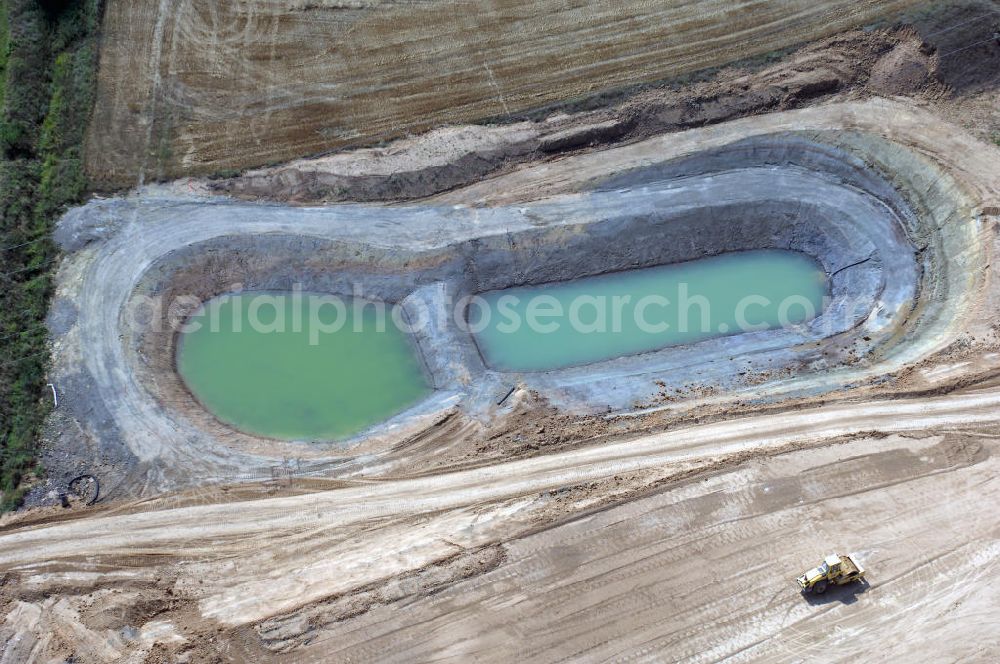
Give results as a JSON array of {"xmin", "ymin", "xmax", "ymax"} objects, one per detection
[{"xmin": 0, "ymin": 0, "xmax": 101, "ymax": 510}]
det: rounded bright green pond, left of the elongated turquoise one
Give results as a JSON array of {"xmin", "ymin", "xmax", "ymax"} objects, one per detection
[{"xmin": 177, "ymin": 292, "xmax": 431, "ymax": 441}]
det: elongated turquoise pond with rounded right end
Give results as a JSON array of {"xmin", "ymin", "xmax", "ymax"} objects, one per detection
[{"xmin": 467, "ymin": 250, "xmax": 827, "ymax": 372}]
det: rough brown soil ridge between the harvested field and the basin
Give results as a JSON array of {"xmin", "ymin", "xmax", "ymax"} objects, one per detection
[{"xmin": 217, "ymin": 27, "xmax": 916, "ymax": 203}]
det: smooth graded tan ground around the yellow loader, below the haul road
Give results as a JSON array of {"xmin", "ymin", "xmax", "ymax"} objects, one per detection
[{"xmin": 308, "ymin": 427, "xmax": 1000, "ymax": 662}]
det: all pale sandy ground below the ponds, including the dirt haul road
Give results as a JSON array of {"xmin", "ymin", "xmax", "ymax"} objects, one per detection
[{"xmin": 0, "ymin": 388, "xmax": 1000, "ymax": 661}]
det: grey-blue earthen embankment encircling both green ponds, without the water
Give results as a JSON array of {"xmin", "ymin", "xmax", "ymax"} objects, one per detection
[{"xmin": 41, "ymin": 100, "xmax": 998, "ymax": 504}]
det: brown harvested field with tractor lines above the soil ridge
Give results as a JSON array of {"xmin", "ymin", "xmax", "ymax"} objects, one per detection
[{"xmin": 87, "ymin": 0, "xmax": 922, "ymax": 187}]
